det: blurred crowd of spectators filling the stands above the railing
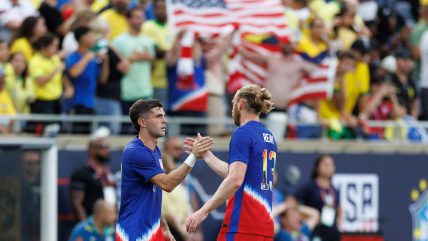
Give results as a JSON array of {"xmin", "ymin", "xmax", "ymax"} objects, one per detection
[{"xmin": 0, "ymin": 0, "xmax": 428, "ymax": 141}]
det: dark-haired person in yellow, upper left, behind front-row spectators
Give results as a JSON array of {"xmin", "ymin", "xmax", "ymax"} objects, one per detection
[{"xmin": 10, "ymin": 16, "xmax": 47, "ymax": 63}]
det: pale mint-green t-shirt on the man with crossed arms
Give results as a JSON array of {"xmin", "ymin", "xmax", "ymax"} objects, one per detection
[{"xmin": 112, "ymin": 33, "xmax": 155, "ymax": 101}]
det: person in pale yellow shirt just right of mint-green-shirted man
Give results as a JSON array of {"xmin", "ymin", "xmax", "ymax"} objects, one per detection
[{"xmin": 143, "ymin": 0, "xmax": 174, "ymax": 103}]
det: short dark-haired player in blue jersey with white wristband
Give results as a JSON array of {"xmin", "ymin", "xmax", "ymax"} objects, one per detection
[{"xmin": 116, "ymin": 100, "xmax": 213, "ymax": 241}]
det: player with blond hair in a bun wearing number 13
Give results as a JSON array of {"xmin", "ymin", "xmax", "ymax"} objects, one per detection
[{"xmin": 185, "ymin": 85, "xmax": 277, "ymax": 241}]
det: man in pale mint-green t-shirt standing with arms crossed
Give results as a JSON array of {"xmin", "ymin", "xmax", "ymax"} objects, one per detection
[{"xmin": 112, "ymin": 8, "xmax": 155, "ymax": 114}]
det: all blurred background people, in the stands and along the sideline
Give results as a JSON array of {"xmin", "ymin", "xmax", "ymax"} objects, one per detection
[{"xmin": 0, "ymin": 0, "xmax": 428, "ymax": 241}]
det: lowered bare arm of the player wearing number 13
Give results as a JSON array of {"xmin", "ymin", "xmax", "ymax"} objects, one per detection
[{"xmin": 186, "ymin": 161, "xmax": 247, "ymax": 232}]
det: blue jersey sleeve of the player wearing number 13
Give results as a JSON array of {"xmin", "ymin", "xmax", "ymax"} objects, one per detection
[{"xmin": 229, "ymin": 129, "xmax": 252, "ymax": 165}]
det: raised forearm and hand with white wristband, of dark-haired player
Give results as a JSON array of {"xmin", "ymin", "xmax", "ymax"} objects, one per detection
[{"xmin": 150, "ymin": 137, "xmax": 213, "ymax": 192}]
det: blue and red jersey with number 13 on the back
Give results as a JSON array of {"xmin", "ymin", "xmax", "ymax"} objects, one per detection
[{"xmin": 220, "ymin": 121, "xmax": 277, "ymax": 237}]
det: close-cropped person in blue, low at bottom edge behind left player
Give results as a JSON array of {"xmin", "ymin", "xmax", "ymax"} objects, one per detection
[{"xmin": 69, "ymin": 199, "xmax": 117, "ymax": 241}]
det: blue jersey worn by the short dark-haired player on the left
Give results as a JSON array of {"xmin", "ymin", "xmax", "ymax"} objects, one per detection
[{"xmin": 116, "ymin": 137, "xmax": 164, "ymax": 241}]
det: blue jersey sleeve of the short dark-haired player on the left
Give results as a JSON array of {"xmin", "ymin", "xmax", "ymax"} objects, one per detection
[{"xmin": 129, "ymin": 151, "xmax": 163, "ymax": 182}]
